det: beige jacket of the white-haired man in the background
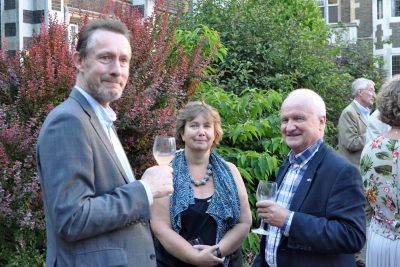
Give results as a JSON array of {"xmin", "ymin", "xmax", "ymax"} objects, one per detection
[{"xmin": 338, "ymin": 102, "xmax": 367, "ymax": 167}]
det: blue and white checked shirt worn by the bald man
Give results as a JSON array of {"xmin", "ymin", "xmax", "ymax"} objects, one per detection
[{"xmin": 265, "ymin": 139, "xmax": 323, "ymax": 267}]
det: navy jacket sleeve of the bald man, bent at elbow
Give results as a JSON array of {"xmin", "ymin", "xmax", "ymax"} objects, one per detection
[{"xmin": 288, "ymin": 164, "xmax": 366, "ymax": 253}]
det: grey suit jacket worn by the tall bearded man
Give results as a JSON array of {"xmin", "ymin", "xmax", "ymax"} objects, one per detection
[{"xmin": 37, "ymin": 90, "xmax": 156, "ymax": 267}]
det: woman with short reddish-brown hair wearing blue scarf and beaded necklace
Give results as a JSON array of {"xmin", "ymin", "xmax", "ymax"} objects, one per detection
[{"xmin": 151, "ymin": 101, "xmax": 251, "ymax": 267}]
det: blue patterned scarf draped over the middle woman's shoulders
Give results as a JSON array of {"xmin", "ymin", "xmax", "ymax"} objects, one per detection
[{"xmin": 170, "ymin": 150, "xmax": 240, "ymax": 266}]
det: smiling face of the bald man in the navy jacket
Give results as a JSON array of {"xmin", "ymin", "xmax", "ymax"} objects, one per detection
[{"xmin": 281, "ymin": 96, "xmax": 326, "ymax": 154}]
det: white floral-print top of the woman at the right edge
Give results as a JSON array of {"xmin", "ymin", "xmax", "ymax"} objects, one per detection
[{"xmin": 360, "ymin": 136, "xmax": 400, "ymax": 240}]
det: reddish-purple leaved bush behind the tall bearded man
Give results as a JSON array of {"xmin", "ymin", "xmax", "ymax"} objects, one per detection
[{"xmin": 0, "ymin": 1, "xmax": 217, "ymax": 232}]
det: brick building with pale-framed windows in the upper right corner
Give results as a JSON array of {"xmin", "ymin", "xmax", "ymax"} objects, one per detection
[{"xmin": 316, "ymin": 0, "xmax": 400, "ymax": 77}]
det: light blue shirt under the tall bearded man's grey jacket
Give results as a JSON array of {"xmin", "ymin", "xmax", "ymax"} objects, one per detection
[{"xmin": 75, "ymin": 85, "xmax": 153, "ymax": 205}]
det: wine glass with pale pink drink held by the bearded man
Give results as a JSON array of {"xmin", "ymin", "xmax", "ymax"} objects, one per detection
[{"xmin": 153, "ymin": 135, "xmax": 176, "ymax": 166}]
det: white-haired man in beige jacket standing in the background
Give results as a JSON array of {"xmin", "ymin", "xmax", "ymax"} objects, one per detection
[{"xmin": 338, "ymin": 78, "xmax": 376, "ymax": 167}]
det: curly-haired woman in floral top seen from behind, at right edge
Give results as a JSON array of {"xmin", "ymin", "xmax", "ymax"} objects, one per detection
[{"xmin": 360, "ymin": 76, "xmax": 400, "ymax": 267}]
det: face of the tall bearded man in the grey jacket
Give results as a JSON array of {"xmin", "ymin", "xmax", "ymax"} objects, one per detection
[{"xmin": 75, "ymin": 30, "xmax": 131, "ymax": 106}]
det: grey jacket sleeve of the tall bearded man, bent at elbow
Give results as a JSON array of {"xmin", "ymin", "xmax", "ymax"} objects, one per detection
[{"xmin": 37, "ymin": 113, "xmax": 150, "ymax": 241}]
